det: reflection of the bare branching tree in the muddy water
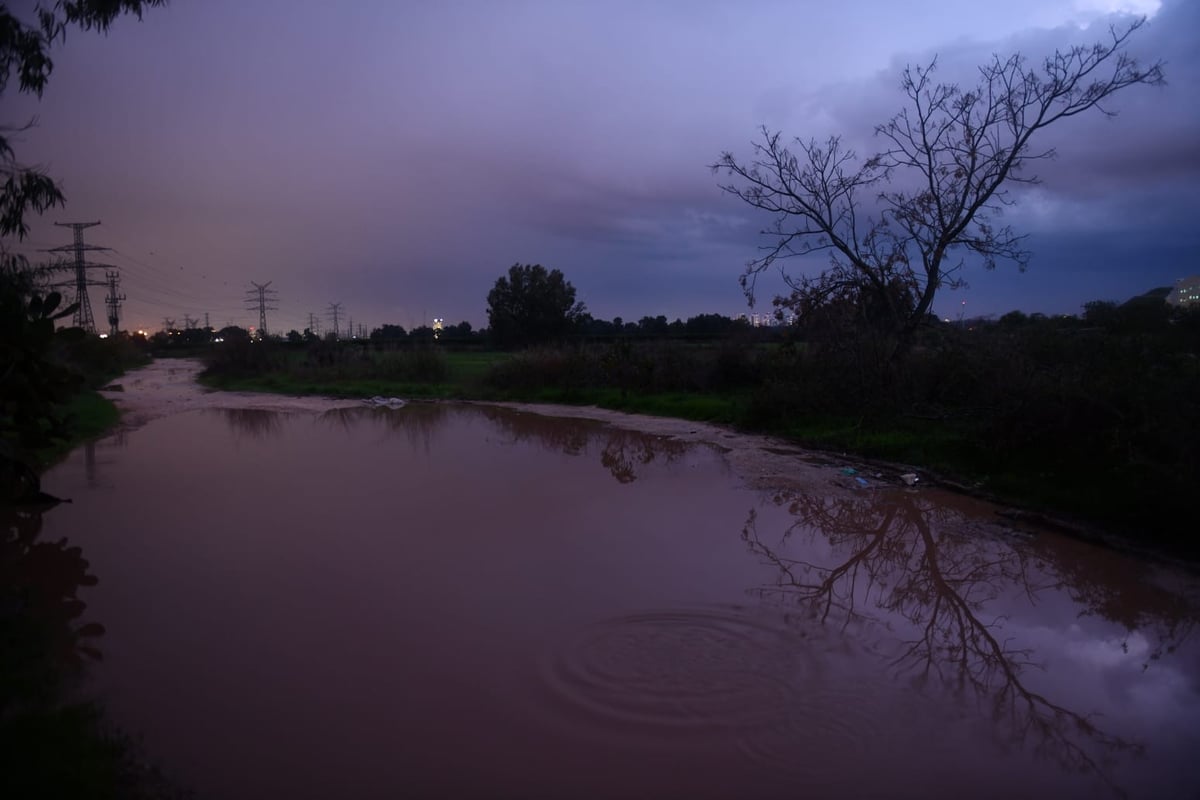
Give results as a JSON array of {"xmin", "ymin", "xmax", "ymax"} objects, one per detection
[{"xmin": 742, "ymin": 492, "xmax": 1194, "ymax": 793}]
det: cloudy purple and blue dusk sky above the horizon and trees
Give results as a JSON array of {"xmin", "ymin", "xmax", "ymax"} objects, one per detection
[{"xmin": 0, "ymin": 0, "xmax": 1200, "ymax": 332}]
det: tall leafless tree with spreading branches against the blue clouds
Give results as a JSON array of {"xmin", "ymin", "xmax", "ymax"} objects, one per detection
[{"xmin": 713, "ymin": 19, "xmax": 1163, "ymax": 353}]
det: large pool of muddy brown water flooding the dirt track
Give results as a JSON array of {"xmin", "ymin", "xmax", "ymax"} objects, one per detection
[{"xmin": 35, "ymin": 367, "xmax": 1200, "ymax": 798}]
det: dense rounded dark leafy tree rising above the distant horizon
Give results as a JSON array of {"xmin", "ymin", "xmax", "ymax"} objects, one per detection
[{"xmin": 487, "ymin": 264, "xmax": 584, "ymax": 347}]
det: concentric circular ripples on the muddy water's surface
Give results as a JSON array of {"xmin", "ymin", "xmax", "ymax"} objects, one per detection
[{"xmin": 544, "ymin": 609, "xmax": 811, "ymax": 729}]
